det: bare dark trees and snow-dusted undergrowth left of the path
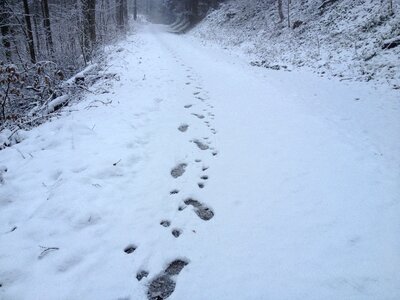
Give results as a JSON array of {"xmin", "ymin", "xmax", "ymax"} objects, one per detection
[{"xmin": 0, "ymin": 0, "xmax": 134, "ymax": 144}]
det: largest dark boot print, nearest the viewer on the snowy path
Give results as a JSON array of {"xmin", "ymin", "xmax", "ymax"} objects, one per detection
[{"xmin": 147, "ymin": 259, "xmax": 188, "ymax": 300}]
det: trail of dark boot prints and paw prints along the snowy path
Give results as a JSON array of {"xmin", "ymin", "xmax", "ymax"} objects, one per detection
[{"xmin": 124, "ymin": 55, "xmax": 218, "ymax": 300}]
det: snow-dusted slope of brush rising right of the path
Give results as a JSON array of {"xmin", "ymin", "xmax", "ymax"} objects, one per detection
[{"xmin": 193, "ymin": 0, "xmax": 400, "ymax": 88}]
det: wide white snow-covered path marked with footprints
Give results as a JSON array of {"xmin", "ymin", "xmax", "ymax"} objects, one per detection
[{"xmin": 0, "ymin": 26, "xmax": 400, "ymax": 300}]
